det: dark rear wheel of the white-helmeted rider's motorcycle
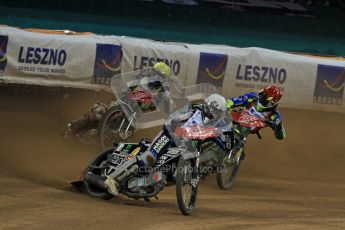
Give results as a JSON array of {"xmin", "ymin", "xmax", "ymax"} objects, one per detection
[{"xmin": 83, "ymin": 148, "xmax": 114, "ymax": 199}]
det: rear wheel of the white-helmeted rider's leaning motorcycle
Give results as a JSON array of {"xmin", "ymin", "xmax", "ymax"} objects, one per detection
[{"xmin": 83, "ymin": 148, "xmax": 114, "ymax": 200}]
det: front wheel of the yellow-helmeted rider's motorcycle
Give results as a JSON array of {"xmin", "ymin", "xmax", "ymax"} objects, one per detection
[{"xmin": 98, "ymin": 106, "xmax": 133, "ymax": 149}]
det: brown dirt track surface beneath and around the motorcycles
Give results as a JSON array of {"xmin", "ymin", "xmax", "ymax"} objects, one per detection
[{"xmin": 0, "ymin": 86, "xmax": 345, "ymax": 229}]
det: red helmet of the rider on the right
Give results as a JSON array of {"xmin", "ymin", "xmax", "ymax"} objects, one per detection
[{"xmin": 258, "ymin": 85, "xmax": 282, "ymax": 109}]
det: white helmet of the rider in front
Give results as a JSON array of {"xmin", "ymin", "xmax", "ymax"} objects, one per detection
[{"xmin": 204, "ymin": 93, "xmax": 226, "ymax": 119}]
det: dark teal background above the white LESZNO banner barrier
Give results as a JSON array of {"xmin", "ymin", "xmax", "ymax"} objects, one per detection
[{"xmin": 0, "ymin": 0, "xmax": 345, "ymax": 56}]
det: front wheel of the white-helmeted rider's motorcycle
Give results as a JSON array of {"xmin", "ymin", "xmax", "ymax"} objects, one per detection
[{"xmin": 176, "ymin": 157, "xmax": 198, "ymax": 215}]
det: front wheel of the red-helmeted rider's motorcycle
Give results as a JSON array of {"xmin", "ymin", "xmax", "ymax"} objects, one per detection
[{"xmin": 217, "ymin": 153, "xmax": 242, "ymax": 189}]
